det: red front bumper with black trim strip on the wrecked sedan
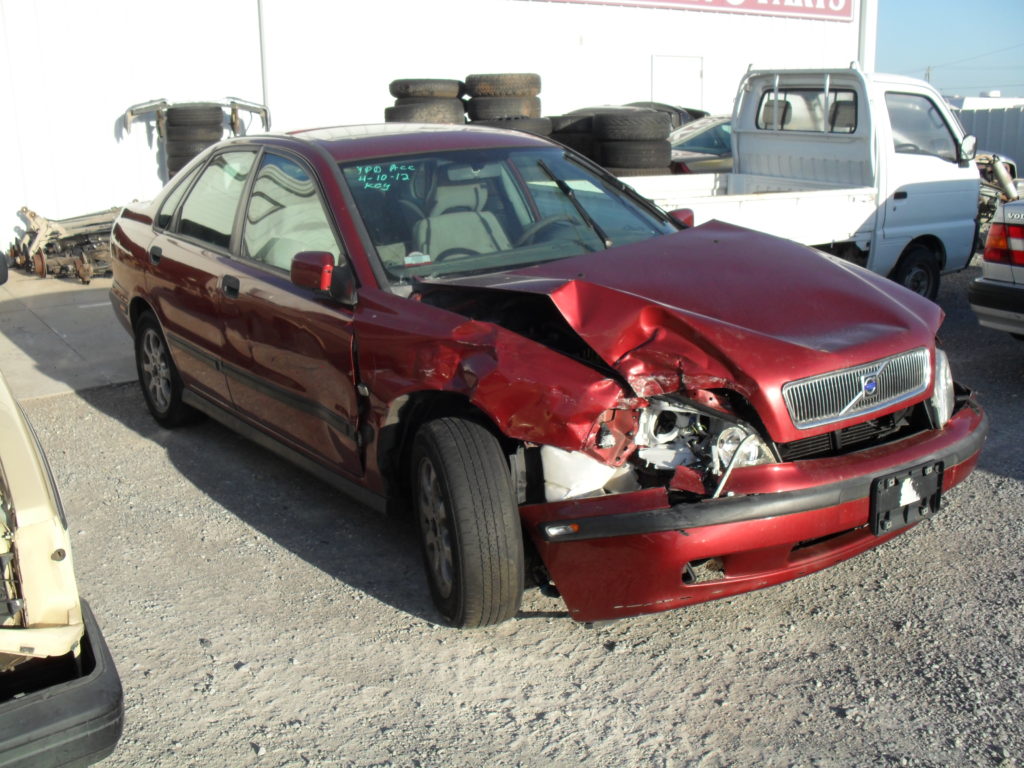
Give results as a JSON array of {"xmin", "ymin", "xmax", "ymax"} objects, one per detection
[{"xmin": 520, "ymin": 397, "xmax": 988, "ymax": 622}]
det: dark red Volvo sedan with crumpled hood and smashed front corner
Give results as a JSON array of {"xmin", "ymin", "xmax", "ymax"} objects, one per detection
[{"xmin": 112, "ymin": 124, "xmax": 987, "ymax": 627}]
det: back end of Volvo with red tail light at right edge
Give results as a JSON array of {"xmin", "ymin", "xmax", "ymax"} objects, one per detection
[{"xmin": 968, "ymin": 195, "xmax": 1024, "ymax": 341}]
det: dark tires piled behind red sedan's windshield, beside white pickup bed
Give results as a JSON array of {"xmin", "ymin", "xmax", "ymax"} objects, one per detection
[{"xmin": 552, "ymin": 108, "xmax": 672, "ymax": 176}]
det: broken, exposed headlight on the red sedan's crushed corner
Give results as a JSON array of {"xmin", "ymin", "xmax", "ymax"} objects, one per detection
[{"xmin": 636, "ymin": 399, "xmax": 777, "ymax": 477}]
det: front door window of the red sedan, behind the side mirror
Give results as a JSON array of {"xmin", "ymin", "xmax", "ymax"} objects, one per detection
[{"xmin": 243, "ymin": 153, "xmax": 341, "ymax": 270}]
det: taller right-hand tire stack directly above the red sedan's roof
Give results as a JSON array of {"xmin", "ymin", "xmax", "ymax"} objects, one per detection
[{"xmin": 466, "ymin": 73, "xmax": 551, "ymax": 136}]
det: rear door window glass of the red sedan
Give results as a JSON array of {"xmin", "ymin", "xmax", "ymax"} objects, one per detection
[{"xmin": 178, "ymin": 152, "xmax": 256, "ymax": 248}]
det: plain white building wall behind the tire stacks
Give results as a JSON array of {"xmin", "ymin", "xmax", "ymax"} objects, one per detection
[{"xmin": 0, "ymin": 0, "xmax": 874, "ymax": 237}]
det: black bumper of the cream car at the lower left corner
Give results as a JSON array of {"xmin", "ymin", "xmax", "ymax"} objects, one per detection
[{"xmin": 0, "ymin": 600, "xmax": 124, "ymax": 768}]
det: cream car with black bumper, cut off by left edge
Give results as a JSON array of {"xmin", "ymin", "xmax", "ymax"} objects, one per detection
[{"xmin": 0, "ymin": 258, "xmax": 123, "ymax": 768}]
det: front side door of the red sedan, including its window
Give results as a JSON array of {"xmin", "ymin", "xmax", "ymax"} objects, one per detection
[{"xmin": 222, "ymin": 152, "xmax": 361, "ymax": 476}]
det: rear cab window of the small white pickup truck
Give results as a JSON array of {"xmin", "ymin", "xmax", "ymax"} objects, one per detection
[{"xmin": 757, "ymin": 88, "xmax": 857, "ymax": 133}]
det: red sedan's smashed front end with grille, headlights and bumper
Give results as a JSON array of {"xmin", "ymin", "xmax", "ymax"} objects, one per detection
[{"xmin": 521, "ymin": 348, "xmax": 988, "ymax": 622}]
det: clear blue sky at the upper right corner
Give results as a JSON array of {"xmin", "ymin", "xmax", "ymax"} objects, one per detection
[{"xmin": 874, "ymin": 0, "xmax": 1024, "ymax": 97}]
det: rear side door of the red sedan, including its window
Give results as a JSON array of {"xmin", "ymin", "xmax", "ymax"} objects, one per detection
[{"xmin": 146, "ymin": 150, "xmax": 256, "ymax": 404}]
